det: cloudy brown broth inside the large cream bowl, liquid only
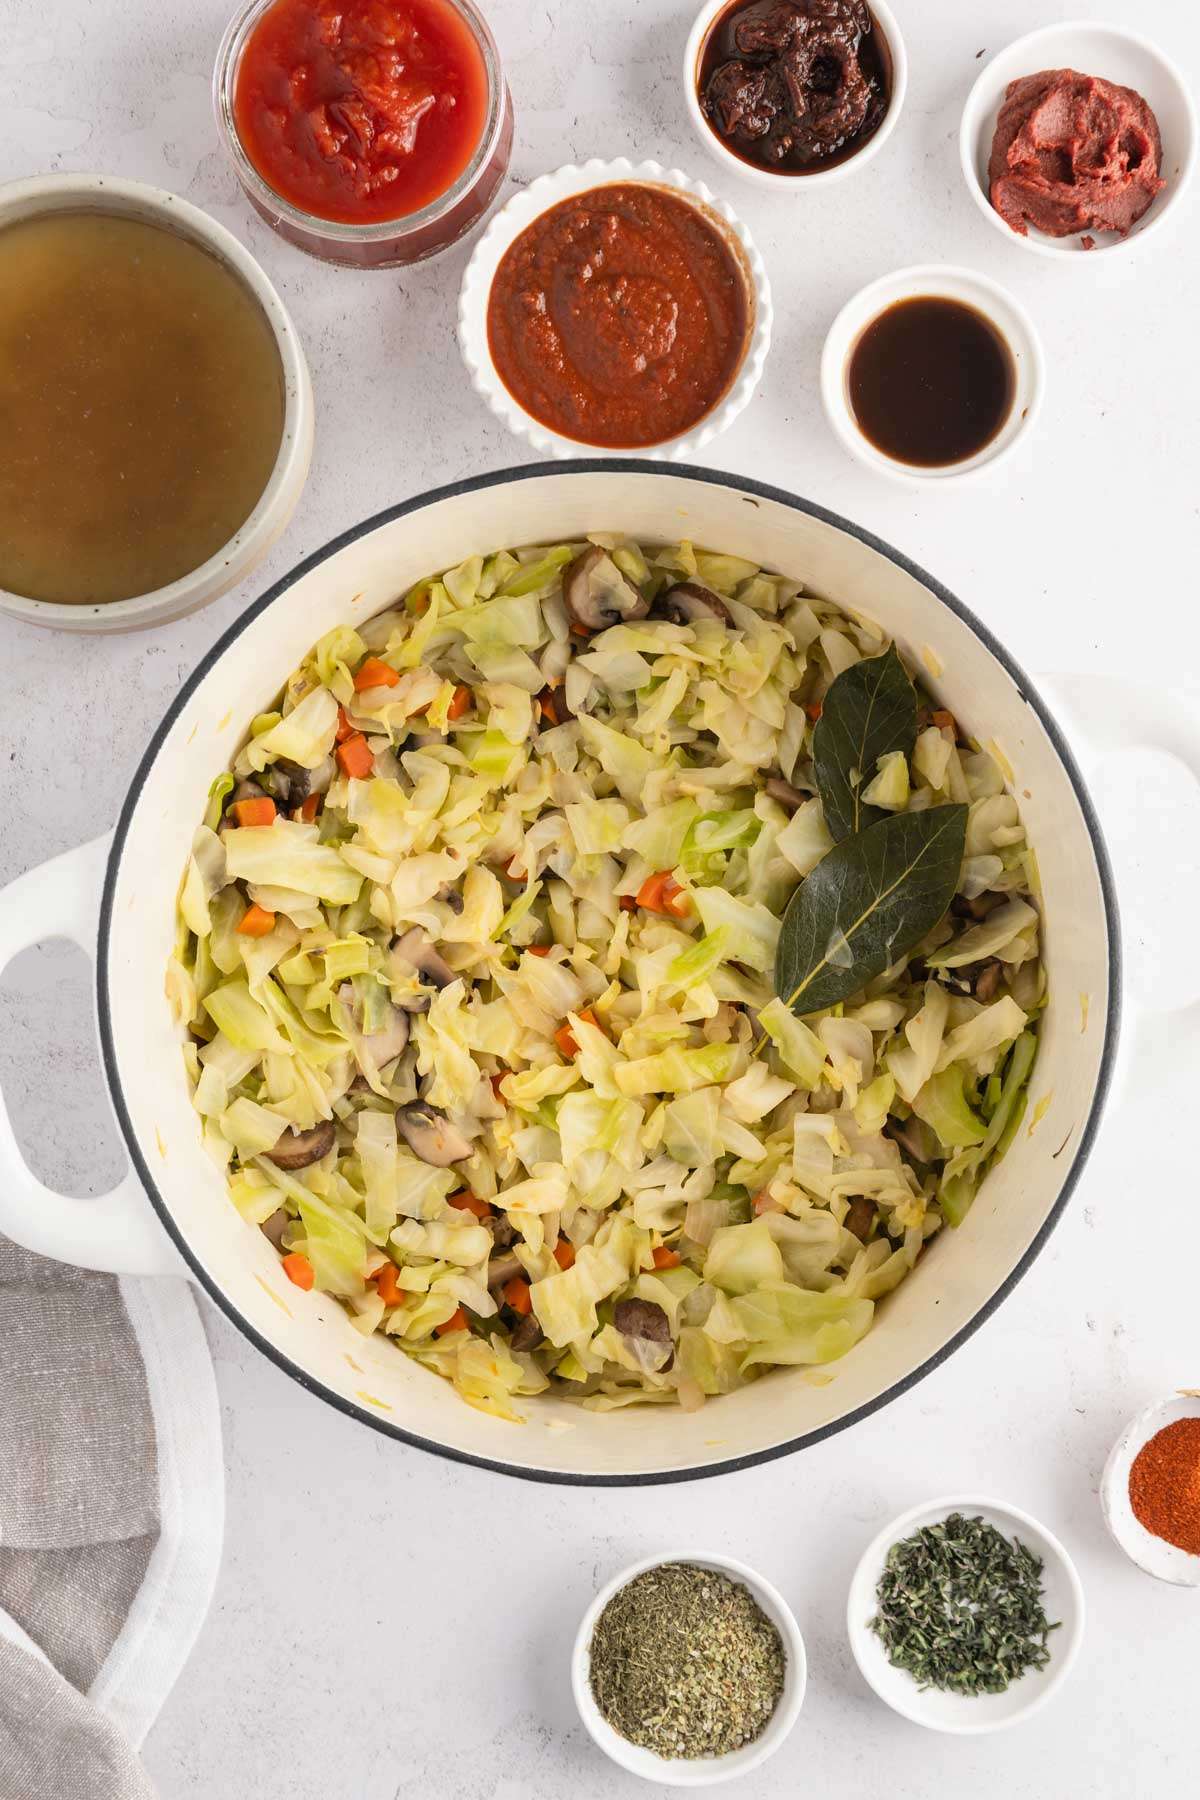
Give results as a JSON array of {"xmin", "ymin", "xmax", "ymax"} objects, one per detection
[{"xmin": 0, "ymin": 212, "xmax": 284, "ymax": 607}]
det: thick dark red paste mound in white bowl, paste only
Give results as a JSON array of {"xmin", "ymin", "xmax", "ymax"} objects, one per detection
[{"xmin": 988, "ymin": 68, "xmax": 1166, "ymax": 250}]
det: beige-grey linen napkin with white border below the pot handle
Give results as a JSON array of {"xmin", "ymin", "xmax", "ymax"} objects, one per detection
[{"xmin": 0, "ymin": 1238, "xmax": 225, "ymax": 1800}]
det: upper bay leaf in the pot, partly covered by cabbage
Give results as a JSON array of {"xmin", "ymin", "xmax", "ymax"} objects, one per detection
[{"xmin": 813, "ymin": 644, "xmax": 918, "ymax": 842}]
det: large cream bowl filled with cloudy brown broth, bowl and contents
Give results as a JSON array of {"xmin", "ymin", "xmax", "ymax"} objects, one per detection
[{"xmin": 0, "ymin": 175, "xmax": 313, "ymax": 632}]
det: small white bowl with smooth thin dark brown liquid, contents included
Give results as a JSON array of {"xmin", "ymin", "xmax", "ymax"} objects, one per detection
[{"xmin": 820, "ymin": 266, "xmax": 1043, "ymax": 482}]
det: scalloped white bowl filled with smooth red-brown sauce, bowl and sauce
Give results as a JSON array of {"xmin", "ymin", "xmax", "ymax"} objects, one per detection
[{"xmin": 459, "ymin": 157, "xmax": 772, "ymax": 461}]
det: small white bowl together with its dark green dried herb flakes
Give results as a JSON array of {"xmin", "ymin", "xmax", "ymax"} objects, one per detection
[{"xmin": 846, "ymin": 1496, "xmax": 1083, "ymax": 1733}]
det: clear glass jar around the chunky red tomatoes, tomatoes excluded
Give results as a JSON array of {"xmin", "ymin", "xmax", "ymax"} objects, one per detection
[{"xmin": 212, "ymin": 0, "xmax": 506, "ymax": 245}]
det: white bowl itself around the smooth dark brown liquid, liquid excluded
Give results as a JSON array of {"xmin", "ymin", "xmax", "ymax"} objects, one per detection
[{"xmin": 820, "ymin": 263, "xmax": 1045, "ymax": 486}]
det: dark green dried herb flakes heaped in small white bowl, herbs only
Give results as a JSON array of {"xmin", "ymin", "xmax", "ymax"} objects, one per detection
[{"xmin": 871, "ymin": 1512, "xmax": 1058, "ymax": 1694}]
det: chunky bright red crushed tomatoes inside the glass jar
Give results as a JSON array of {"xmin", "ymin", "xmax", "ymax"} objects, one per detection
[{"xmin": 234, "ymin": 0, "xmax": 488, "ymax": 225}]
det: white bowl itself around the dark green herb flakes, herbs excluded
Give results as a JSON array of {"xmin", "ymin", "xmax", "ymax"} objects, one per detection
[{"xmin": 846, "ymin": 1494, "xmax": 1083, "ymax": 1737}]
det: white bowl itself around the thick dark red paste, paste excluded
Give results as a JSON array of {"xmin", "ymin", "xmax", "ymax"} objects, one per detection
[{"xmin": 959, "ymin": 20, "xmax": 1196, "ymax": 263}]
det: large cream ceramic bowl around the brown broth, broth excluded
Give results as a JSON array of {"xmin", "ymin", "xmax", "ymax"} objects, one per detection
[{"xmin": 0, "ymin": 175, "xmax": 313, "ymax": 634}]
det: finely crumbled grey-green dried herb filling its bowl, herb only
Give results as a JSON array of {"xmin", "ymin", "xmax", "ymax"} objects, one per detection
[{"xmin": 592, "ymin": 1562, "xmax": 786, "ymax": 1757}]
